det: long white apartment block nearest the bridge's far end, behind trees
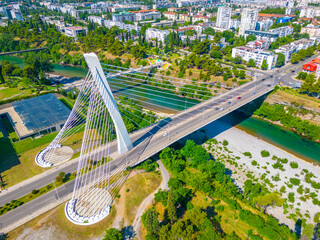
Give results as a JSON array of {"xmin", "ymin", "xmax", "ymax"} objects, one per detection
[{"xmin": 231, "ymin": 47, "xmax": 278, "ymax": 70}]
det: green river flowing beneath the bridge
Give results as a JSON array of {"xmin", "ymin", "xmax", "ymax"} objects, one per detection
[{"xmin": 0, "ymin": 56, "xmax": 320, "ymax": 163}]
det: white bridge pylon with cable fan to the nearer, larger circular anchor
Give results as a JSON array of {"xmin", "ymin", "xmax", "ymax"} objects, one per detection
[{"xmin": 65, "ymin": 53, "xmax": 133, "ymax": 225}]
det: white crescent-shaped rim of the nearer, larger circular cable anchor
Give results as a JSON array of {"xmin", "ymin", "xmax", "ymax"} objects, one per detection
[{"xmin": 64, "ymin": 199, "xmax": 110, "ymax": 225}]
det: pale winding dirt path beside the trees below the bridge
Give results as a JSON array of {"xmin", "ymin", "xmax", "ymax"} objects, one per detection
[{"xmin": 130, "ymin": 160, "xmax": 170, "ymax": 239}]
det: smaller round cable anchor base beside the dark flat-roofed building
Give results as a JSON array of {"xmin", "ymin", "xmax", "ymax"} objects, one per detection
[{"xmin": 35, "ymin": 144, "xmax": 73, "ymax": 168}]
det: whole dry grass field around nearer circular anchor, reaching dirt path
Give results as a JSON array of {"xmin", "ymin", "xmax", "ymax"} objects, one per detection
[{"xmin": 9, "ymin": 172, "xmax": 161, "ymax": 240}]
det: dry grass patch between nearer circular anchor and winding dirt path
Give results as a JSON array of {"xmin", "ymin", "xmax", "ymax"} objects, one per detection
[{"xmin": 123, "ymin": 172, "xmax": 161, "ymax": 224}]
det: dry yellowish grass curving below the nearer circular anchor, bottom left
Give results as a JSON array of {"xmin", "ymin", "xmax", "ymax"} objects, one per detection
[{"xmin": 8, "ymin": 203, "xmax": 116, "ymax": 240}]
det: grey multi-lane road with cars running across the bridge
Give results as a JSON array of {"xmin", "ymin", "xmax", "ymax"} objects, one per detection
[{"xmin": 0, "ymin": 78, "xmax": 274, "ymax": 232}]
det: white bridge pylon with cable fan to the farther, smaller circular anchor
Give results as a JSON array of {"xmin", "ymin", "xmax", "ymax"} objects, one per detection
[{"xmin": 35, "ymin": 53, "xmax": 132, "ymax": 168}]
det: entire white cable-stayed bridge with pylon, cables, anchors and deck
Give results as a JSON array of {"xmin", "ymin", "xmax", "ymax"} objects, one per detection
[{"xmin": 36, "ymin": 53, "xmax": 274, "ymax": 225}]
